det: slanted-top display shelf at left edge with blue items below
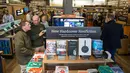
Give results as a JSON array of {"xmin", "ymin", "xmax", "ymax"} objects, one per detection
[{"xmin": 0, "ymin": 20, "xmax": 21, "ymax": 56}]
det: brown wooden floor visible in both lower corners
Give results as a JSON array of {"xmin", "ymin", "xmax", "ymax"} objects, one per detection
[{"xmin": 3, "ymin": 54, "xmax": 130, "ymax": 73}]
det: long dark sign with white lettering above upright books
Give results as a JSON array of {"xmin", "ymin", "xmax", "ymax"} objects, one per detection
[{"xmin": 46, "ymin": 27, "xmax": 101, "ymax": 39}]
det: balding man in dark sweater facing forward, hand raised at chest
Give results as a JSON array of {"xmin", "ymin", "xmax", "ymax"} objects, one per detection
[{"xmin": 30, "ymin": 15, "xmax": 45, "ymax": 52}]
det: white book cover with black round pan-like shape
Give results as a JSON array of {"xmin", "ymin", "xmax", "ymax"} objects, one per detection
[{"xmin": 79, "ymin": 38, "xmax": 92, "ymax": 56}]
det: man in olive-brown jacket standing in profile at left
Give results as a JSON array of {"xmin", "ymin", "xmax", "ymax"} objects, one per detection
[{"xmin": 14, "ymin": 21, "xmax": 34, "ymax": 73}]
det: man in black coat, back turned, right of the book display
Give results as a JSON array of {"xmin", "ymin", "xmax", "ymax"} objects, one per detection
[{"xmin": 101, "ymin": 14, "xmax": 124, "ymax": 61}]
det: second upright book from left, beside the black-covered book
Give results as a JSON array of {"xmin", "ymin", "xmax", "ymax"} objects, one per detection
[{"xmin": 57, "ymin": 40, "xmax": 66, "ymax": 56}]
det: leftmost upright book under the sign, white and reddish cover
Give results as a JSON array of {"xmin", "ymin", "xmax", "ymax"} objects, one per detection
[{"xmin": 46, "ymin": 40, "xmax": 56, "ymax": 55}]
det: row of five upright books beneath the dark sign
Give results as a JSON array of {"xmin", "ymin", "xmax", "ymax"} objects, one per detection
[{"xmin": 46, "ymin": 38, "xmax": 103, "ymax": 56}]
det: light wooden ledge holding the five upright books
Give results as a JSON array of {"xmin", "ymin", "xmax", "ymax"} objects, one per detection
[{"xmin": 43, "ymin": 56, "xmax": 113, "ymax": 64}]
